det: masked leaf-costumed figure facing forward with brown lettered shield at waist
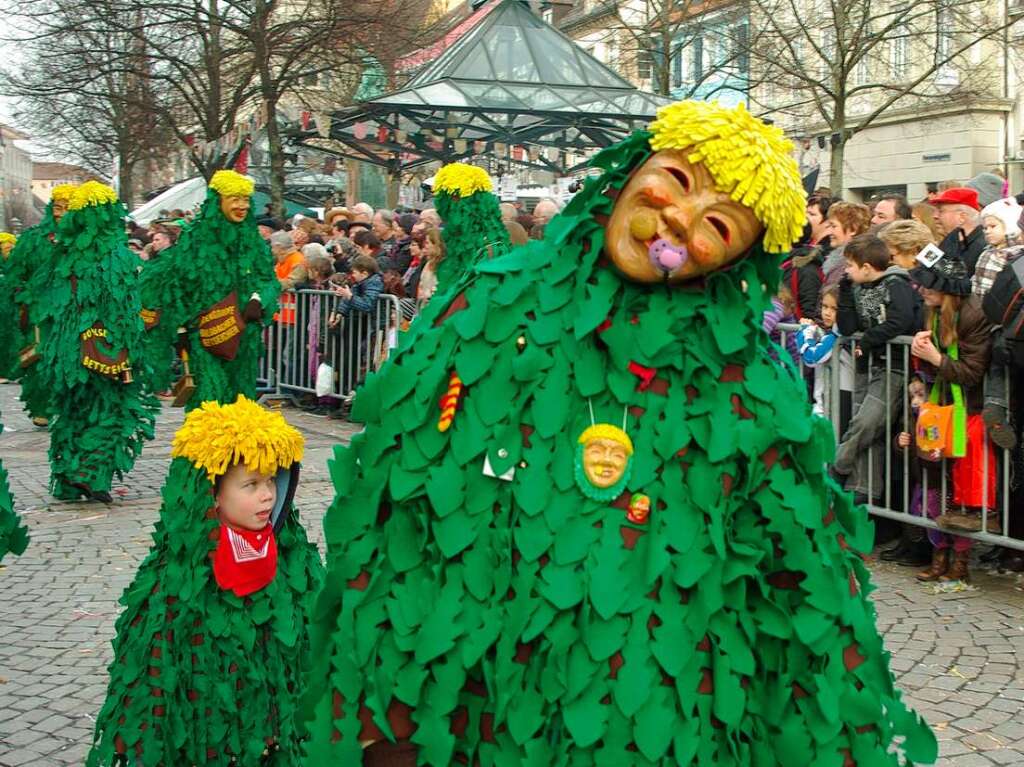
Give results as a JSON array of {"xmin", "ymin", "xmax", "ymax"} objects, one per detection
[{"xmin": 141, "ymin": 170, "xmax": 281, "ymax": 410}]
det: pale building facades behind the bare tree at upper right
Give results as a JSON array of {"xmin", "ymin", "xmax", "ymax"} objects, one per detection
[{"xmin": 559, "ymin": 0, "xmax": 1024, "ymax": 200}]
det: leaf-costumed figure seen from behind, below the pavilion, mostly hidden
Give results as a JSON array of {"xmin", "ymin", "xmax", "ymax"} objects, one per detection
[{"xmin": 434, "ymin": 163, "xmax": 511, "ymax": 295}]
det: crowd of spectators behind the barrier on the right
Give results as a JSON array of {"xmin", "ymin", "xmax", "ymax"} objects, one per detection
[{"xmin": 765, "ymin": 173, "xmax": 1024, "ymax": 582}]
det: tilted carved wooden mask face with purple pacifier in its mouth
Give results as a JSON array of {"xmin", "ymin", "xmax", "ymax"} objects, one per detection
[{"xmin": 604, "ymin": 150, "xmax": 764, "ymax": 284}]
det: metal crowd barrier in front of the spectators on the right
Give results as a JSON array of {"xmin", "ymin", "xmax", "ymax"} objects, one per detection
[{"xmin": 775, "ymin": 324, "xmax": 1024, "ymax": 550}]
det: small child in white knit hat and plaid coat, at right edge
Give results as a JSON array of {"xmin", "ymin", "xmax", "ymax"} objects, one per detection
[{"xmin": 971, "ymin": 197, "xmax": 1024, "ymax": 450}]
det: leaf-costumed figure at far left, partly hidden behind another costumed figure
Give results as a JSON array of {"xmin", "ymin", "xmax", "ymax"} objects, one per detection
[{"xmin": 0, "ymin": 184, "xmax": 77, "ymax": 427}]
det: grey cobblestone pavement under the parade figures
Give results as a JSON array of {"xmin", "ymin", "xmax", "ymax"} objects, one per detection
[{"xmin": 0, "ymin": 385, "xmax": 1024, "ymax": 767}]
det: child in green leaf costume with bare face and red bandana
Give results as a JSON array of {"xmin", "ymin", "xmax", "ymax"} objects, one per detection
[{"xmin": 86, "ymin": 396, "xmax": 323, "ymax": 767}]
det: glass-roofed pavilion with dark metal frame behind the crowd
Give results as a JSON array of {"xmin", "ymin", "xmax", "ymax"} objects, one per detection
[{"xmin": 291, "ymin": 0, "xmax": 670, "ymax": 174}]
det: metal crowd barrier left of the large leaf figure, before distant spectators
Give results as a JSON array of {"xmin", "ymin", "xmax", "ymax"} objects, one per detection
[{"xmin": 260, "ymin": 290, "xmax": 401, "ymax": 400}]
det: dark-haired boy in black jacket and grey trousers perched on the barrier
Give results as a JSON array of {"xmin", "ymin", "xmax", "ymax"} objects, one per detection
[{"xmin": 833, "ymin": 235, "xmax": 922, "ymax": 500}]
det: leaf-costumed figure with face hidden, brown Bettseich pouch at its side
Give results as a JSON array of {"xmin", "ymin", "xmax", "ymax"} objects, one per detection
[{"xmin": 38, "ymin": 181, "xmax": 160, "ymax": 502}]
